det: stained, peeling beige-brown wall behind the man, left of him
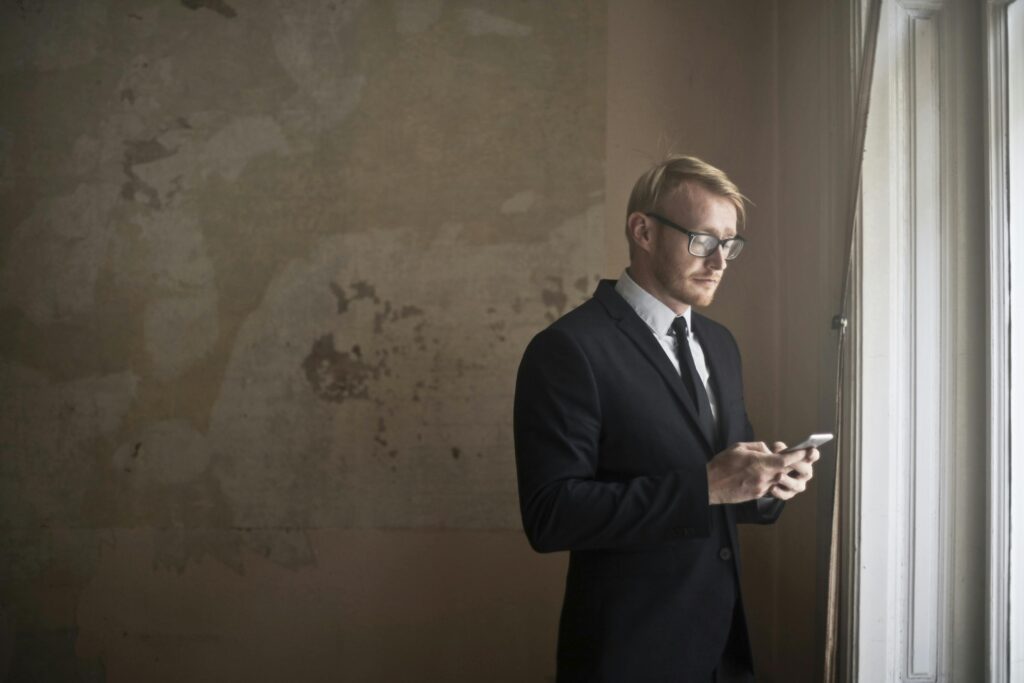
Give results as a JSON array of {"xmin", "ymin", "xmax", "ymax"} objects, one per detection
[{"xmin": 0, "ymin": 0, "xmax": 606, "ymax": 681}]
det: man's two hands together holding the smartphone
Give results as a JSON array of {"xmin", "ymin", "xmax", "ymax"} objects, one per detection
[{"xmin": 708, "ymin": 441, "xmax": 820, "ymax": 505}]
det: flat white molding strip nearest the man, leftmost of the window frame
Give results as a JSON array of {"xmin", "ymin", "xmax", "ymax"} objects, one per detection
[{"xmin": 848, "ymin": 3, "xmax": 906, "ymax": 683}]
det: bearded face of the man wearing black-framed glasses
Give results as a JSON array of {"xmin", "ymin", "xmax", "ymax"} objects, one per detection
[{"xmin": 647, "ymin": 182, "xmax": 736, "ymax": 308}]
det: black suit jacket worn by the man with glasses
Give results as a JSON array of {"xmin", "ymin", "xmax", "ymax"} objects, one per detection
[{"xmin": 514, "ymin": 281, "xmax": 782, "ymax": 683}]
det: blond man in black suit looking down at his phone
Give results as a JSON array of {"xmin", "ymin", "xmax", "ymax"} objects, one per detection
[{"xmin": 514, "ymin": 156, "xmax": 818, "ymax": 683}]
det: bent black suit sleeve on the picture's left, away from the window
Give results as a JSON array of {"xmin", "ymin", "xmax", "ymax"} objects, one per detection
[{"xmin": 513, "ymin": 328, "xmax": 709, "ymax": 552}]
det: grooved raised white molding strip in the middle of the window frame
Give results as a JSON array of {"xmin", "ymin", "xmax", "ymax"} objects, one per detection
[{"xmin": 892, "ymin": 2, "xmax": 955, "ymax": 681}]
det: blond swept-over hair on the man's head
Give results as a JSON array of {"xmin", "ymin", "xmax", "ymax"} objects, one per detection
[{"xmin": 626, "ymin": 155, "xmax": 750, "ymax": 229}]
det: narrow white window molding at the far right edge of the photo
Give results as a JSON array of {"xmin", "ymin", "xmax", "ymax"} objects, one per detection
[{"xmin": 984, "ymin": 0, "xmax": 1024, "ymax": 683}]
